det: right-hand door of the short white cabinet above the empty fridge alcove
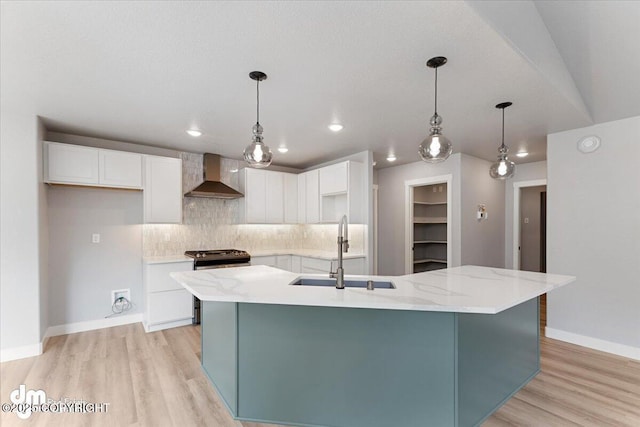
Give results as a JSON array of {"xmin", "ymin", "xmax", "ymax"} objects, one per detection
[{"xmin": 99, "ymin": 150, "xmax": 142, "ymax": 188}]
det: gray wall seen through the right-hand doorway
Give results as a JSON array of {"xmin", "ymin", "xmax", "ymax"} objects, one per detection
[{"xmin": 520, "ymin": 185, "xmax": 547, "ymax": 271}]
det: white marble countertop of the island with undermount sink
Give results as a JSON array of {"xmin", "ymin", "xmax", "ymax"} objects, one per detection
[{"xmin": 171, "ymin": 265, "xmax": 575, "ymax": 314}]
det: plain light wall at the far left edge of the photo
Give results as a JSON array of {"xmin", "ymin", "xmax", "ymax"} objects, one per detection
[{"xmin": 0, "ymin": 110, "xmax": 44, "ymax": 360}]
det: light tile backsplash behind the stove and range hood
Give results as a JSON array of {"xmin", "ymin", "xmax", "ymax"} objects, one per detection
[{"xmin": 142, "ymin": 153, "xmax": 364, "ymax": 257}]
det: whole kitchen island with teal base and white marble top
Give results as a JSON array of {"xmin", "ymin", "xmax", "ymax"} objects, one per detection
[{"xmin": 171, "ymin": 266, "xmax": 575, "ymax": 427}]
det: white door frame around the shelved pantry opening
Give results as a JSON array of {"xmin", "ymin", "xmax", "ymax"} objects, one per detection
[{"xmin": 404, "ymin": 174, "xmax": 453, "ymax": 274}]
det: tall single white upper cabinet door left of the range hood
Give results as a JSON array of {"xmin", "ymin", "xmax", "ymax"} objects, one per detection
[{"xmin": 143, "ymin": 156, "xmax": 182, "ymax": 223}]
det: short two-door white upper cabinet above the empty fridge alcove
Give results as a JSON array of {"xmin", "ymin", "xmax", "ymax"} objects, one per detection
[{"xmin": 44, "ymin": 142, "xmax": 142, "ymax": 189}]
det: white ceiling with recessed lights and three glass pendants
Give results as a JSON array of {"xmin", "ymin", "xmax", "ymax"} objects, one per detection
[{"xmin": 0, "ymin": 1, "xmax": 640, "ymax": 168}]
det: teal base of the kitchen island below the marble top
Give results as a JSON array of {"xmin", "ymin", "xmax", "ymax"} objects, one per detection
[{"xmin": 202, "ymin": 299, "xmax": 540, "ymax": 427}]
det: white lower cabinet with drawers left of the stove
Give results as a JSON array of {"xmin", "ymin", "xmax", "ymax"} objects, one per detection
[{"xmin": 143, "ymin": 261, "xmax": 193, "ymax": 332}]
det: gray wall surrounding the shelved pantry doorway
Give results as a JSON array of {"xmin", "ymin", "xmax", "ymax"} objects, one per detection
[{"xmin": 378, "ymin": 154, "xmax": 461, "ymax": 275}]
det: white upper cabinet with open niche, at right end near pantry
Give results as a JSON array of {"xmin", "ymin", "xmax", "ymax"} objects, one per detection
[{"xmin": 319, "ymin": 161, "xmax": 364, "ymax": 223}]
